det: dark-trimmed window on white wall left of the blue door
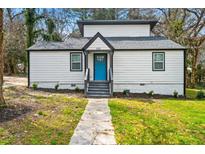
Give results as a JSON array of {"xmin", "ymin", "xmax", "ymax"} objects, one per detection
[{"xmin": 70, "ymin": 53, "xmax": 82, "ymax": 71}]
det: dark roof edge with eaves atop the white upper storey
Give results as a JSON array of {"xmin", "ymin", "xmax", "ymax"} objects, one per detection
[{"xmin": 77, "ymin": 20, "xmax": 158, "ymax": 34}]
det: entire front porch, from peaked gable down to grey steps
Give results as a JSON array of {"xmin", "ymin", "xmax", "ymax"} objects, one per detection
[{"xmin": 83, "ymin": 33, "xmax": 114, "ymax": 97}]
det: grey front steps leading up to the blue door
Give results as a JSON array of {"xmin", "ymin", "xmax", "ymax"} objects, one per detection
[{"xmin": 87, "ymin": 81, "xmax": 110, "ymax": 98}]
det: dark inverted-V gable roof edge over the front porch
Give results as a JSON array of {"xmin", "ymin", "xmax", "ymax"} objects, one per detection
[{"xmin": 83, "ymin": 32, "xmax": 114, "ymax": 50}]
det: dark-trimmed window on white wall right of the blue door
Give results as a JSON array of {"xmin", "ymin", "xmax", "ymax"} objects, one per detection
[{"xmin": 152, "ymin": 52, "xmax": 165, "ymax": 71}]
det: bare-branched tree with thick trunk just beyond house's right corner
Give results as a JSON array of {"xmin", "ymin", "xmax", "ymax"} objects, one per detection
[{"xmin": 158, "ymin": 9, "xmax": 205, "ymax": 87}]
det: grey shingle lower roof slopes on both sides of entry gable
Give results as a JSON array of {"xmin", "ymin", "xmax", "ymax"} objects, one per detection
[{"xmin": 28, "ymin": 36, "xmax": 185, "ymax": 51}]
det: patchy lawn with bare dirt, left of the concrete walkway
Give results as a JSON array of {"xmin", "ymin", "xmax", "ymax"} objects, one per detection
[{"xmin": 0, "ymin": 86, "xmax": 87, "ymax": 144}]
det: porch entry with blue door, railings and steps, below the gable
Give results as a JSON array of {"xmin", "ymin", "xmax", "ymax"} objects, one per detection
[{"xmin": 84, "ymin": 51, "xmax": 113, "ymax": 97}]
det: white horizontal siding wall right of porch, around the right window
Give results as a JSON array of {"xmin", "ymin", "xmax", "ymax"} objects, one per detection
[{"xmin": 113, "ymin": 50, "xmax": 184, "ymax": 95}]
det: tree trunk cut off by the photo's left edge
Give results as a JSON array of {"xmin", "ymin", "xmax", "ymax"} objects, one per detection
[{"xmin": 0, "ymin": 9, "xmax": 5, "ymax": 106}]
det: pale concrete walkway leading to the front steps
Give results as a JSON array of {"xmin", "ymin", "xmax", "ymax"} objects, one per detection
[{"xmin": 70, "ymin": 99, "xmax": 116, "ymax": 145}]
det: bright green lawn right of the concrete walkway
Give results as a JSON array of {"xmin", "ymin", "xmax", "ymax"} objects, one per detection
[{"xmin": 109, "ymin": 99, "xmax": 205, "ymax": 144}]
